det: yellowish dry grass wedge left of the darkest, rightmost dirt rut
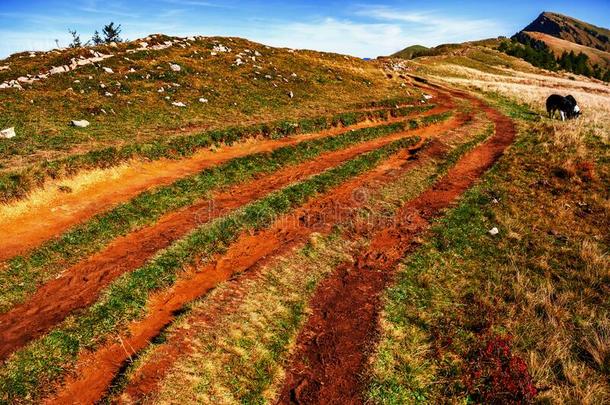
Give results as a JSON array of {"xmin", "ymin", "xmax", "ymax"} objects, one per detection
[{"xmin": 135, "ymin": 112, "xmax": 489, "ymax": 403}]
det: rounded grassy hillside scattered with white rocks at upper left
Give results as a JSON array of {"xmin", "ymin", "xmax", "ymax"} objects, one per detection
[{"xmin": 0, "ymin": 35, "xmax": 416, "ymax": 170}]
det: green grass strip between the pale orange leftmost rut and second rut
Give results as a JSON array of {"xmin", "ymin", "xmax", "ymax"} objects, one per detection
[{"xmin": 0, "ymin": 110, "xmax": 449, "ymax": 312}]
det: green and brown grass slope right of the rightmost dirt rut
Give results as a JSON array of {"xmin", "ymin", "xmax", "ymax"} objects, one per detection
[{"xmin": 368, "ymin": 94, "xmax": 610, "ymax": 404}]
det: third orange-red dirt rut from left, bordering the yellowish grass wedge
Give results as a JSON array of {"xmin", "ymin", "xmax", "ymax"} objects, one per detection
[{"xmin": 42, "ymin": 128, "xmax": 448, "ymax": 404}]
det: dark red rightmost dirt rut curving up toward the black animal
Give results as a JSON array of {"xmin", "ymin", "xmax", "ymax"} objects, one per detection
[{"xmin": 278, "ymin": 100, "xmax": 516, "ymax": 404}]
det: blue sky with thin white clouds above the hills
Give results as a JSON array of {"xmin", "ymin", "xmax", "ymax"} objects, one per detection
[{"xmin": 0, "ymin": 0, "xmax": 610, "ymax": 58}]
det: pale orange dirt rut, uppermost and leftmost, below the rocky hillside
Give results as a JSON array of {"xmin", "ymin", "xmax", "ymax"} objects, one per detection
[{"xmin": 0, "ymin": 97, "xmax": 452, "ymax": 262}]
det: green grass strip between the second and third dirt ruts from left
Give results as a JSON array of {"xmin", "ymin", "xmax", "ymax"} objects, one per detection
[{"xmin": 0, "ymin": 137, "xmax": 419, "ymax": 403}]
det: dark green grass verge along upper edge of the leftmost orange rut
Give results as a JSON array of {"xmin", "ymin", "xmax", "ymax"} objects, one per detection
[{"xmin": 0, "ymin": 105, "xmax": 433, "ymax": 203}]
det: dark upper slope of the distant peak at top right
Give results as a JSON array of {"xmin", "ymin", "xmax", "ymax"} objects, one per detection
[{"xmin": 523, "ymin": 12, "xmax": 610, "ymax": 52}]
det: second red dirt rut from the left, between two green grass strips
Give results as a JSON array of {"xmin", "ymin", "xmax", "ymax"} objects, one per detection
[{"xmin": 0, "ymin": 109, "xmax": 471, "ymax": 360}]
